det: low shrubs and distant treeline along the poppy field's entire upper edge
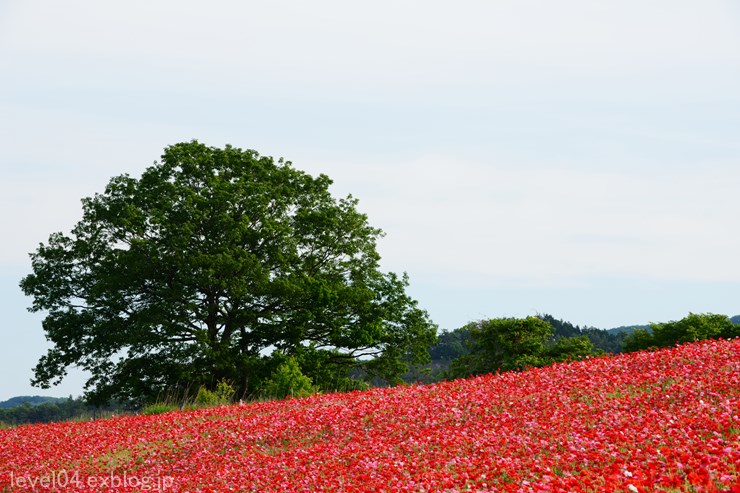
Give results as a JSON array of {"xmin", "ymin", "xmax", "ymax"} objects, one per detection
[{"xmin": 7, "ymin": 313, "xmax": 740, "ymax": 426}]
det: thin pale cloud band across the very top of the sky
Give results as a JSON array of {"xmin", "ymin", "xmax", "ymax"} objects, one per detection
[{"xmin": 0, "ymin": 0, "xmax": 740, "ymax": 96}]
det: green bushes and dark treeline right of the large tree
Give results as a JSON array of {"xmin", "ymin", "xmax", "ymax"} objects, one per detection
[{"xmin": 407, "ymin": 313, "xmax": 740, "ymax": 382}]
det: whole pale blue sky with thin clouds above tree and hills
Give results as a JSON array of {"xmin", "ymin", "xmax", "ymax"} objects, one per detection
[{"xmin": 0, "ymin": 0, "xmax": 740, "ymax": 400}]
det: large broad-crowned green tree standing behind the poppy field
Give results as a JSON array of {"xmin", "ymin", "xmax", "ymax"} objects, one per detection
[{"xmin": 21, "ymin": 141, "xmax": 436, "ymax": 402}]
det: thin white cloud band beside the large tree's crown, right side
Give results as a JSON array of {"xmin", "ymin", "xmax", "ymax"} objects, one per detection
[{"xmin": 322, "ymin": 157, "xmax": 740, "ymax": 286}]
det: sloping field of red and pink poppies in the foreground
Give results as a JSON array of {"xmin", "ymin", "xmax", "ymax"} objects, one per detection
[{"xmin": 0, "ymin": 339, "xmax": 740, "ymax": 493}]
